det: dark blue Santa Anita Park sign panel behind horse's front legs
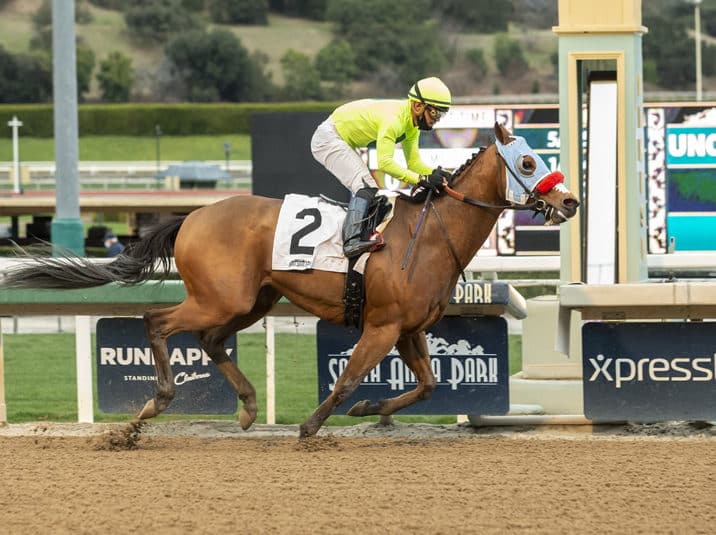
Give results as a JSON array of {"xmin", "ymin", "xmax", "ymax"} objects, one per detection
[{"xmin": 317, "ymin": 316, "xmax": 510, "ymax": 415}]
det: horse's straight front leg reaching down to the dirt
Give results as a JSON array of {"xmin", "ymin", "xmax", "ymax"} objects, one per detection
[{"xmin": 300, "ymin": 325, "xmax": 400, "ymax": 438}]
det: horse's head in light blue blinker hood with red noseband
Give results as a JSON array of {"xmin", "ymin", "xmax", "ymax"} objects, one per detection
[{"xmin": 495, "ymin": 123, "xmax": 579, "ymax": 224}]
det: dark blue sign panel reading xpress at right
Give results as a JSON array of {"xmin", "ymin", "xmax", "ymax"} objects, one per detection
[{"xmin": 582, "ymin": 322, "xmax": 716, "ymax": 422}]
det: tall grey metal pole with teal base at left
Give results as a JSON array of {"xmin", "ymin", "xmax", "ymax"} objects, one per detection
[{"xmin": 52, "ymin": 0, "xmax": 85, "ymax": 256}]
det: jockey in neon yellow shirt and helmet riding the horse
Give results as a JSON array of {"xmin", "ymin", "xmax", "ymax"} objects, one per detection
[{"xmin": 311, "ymin": 77, "xmax": 452, "ymax": 258}]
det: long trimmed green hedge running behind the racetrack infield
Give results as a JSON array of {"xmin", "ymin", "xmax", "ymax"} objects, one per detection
[{"xmin": 0, "ymin": 102, "xmax": 339, "ymax": 138}]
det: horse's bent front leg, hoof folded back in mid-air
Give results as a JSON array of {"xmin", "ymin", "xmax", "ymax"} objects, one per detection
[{"xmin": 348, "ymin": 332, "xmax": 435, "ymax": 416}]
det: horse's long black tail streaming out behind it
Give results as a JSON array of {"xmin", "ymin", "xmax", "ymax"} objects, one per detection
[{"xmin": 0, "ymin": 216, "xmax": 184, "ymax": 290}]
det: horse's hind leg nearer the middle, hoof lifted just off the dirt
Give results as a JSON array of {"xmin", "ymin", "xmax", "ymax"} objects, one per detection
[{"xmin": 199, "ymin": 287, "xmax": 281, "ymax": 429}]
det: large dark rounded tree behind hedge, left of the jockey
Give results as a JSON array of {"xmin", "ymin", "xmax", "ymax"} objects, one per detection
[{"xmin": 165, "ymin": 30, "xmax": 273, "ymax": 102}]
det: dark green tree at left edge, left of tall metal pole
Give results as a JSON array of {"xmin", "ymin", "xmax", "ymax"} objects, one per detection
[{"xmin": 0, "ymin": 45, "xmax": 52, "ymax": 104}]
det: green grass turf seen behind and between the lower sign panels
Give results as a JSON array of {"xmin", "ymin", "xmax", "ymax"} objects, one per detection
[{"xmin": 3, "ymin": 333, "xmax": 522, "ymax": 425}]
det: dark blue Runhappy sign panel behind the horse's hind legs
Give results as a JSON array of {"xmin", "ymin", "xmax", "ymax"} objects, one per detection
[{"xmin": 97, "ymin": 318, "xmax": 237, "ymax": 414}]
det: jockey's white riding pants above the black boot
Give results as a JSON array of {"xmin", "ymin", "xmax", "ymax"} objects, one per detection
[{"xmin": 311, "ymin": 117, "xmax": 378, "ymax": 194}]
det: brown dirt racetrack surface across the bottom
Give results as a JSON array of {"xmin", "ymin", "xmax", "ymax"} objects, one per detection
[{"xmin": 0, "ymin": 422, "xmax": 716, "ymax": 534}]
